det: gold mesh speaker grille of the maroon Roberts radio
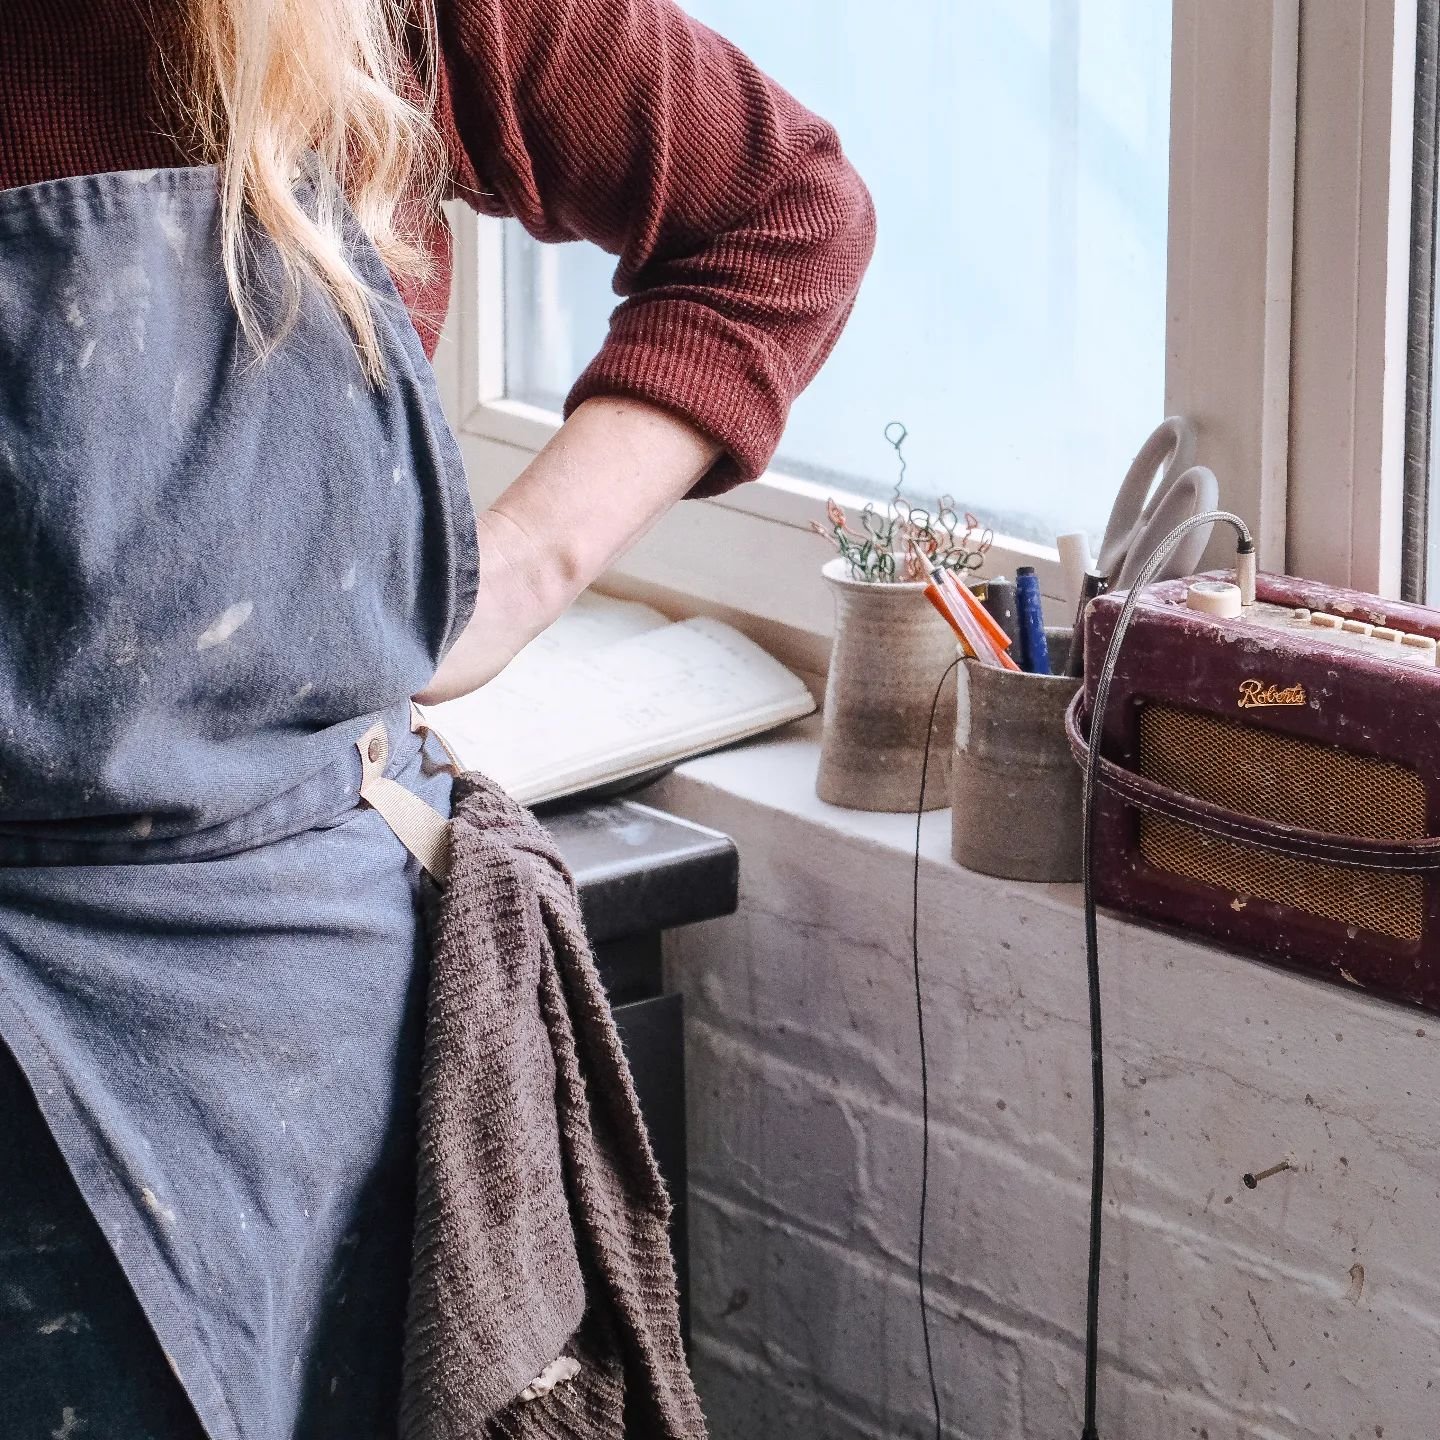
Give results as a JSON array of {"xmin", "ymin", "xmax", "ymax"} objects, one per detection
[{"xmin": 1140, "ymin": 704, "xmax": 1426, "ymax": 942}]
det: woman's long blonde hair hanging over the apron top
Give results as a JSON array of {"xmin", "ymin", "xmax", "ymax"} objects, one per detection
[{"xmin": 179, "ymin": 0, "xmax": 439, "ymax": 383}]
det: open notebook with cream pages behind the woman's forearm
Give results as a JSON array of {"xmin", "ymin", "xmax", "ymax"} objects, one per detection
[{"xmin": 419, "ymin": 593, "xmax": 815, "ymax": 805}]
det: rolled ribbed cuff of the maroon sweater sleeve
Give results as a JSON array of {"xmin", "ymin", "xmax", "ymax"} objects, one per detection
[{"xmin": 564, "ymin": 298, "xmax": 792, "ymax": 497}]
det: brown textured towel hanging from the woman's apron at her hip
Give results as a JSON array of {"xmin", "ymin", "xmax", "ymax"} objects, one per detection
[{"xmin": 400, "ymin": 775, "xmax": 706, "ymax": 1440}]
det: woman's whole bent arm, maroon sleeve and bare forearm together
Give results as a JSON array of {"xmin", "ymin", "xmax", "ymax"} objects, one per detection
[{"xmin": 420, "ymin": 0, "xmax": 874, "ymax": 701}]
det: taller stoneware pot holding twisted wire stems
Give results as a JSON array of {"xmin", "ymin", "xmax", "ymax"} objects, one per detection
[{"xmin": 815, "ymin": 556, "xmax": 955, "ymax": 811}]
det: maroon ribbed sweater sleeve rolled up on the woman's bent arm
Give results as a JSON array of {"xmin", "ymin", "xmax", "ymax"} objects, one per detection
[{"xmin": 439, "ymin": 0, "xmax": 874, "ymax": 494}]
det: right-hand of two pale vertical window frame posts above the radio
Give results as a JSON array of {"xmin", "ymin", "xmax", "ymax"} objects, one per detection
[{"xmin": 1287, "ymin": 0, "xmax": 1417, "ymax": 596}]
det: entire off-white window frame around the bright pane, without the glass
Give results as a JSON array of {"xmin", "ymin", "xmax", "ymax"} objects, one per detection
[{"xmin": 436, "ymin": 0, "xmax": 1416, "ymax": 639}]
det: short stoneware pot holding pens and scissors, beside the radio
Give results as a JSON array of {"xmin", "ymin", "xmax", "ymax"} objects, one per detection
[{"xmin": 950, "ymin": 629, "xmax": 1080, "ymax": 880}]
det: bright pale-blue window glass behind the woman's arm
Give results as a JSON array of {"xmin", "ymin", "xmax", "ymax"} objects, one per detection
[{"xmin": 505, "ymin": 0, "xmax": 1171, "ymax": 543}]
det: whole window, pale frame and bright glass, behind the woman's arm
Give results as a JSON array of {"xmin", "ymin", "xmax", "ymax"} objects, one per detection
[{"xmin": 434, "ymin": 0, "xmax": 1416, "ymax": 639}]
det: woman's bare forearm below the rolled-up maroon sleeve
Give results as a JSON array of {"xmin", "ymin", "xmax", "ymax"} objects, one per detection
[{"xmin": 415, "ymin": 396, "xmax": 720, "ymax": 704}]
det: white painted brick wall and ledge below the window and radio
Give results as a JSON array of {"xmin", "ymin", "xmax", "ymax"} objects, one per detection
[{"xmin": 652, "ymin": 737, "xmax": 1440, "ymax": 1440}]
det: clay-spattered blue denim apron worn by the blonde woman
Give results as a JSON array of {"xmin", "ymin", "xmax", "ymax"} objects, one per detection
[{"xmin": 0, "ymin": 168, "xmax": 477, "ymax": 1440}]
